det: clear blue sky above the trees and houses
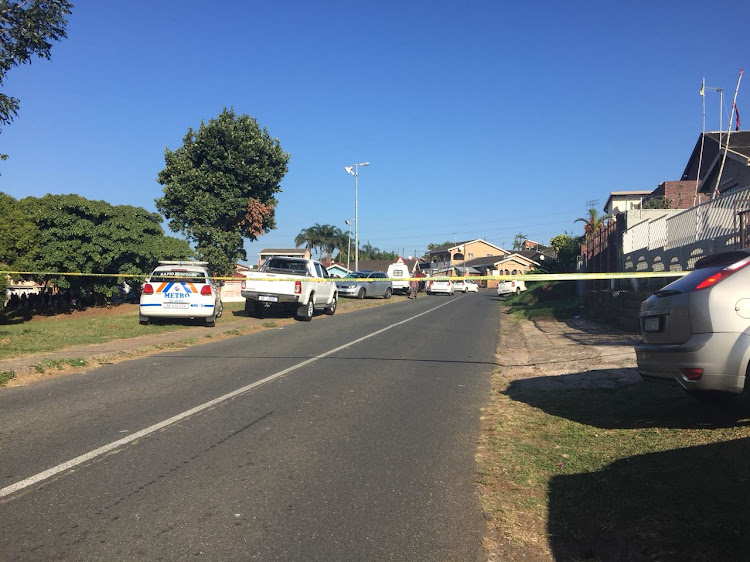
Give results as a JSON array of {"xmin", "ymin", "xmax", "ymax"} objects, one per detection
[{"xmin": 0, "ymin": 0, "xmax": 750, "ymax": 262}]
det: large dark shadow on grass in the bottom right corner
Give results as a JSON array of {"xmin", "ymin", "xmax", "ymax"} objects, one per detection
[{"xmin": 548, "ymin": 438, "xmax": 750, "ymax": 561}]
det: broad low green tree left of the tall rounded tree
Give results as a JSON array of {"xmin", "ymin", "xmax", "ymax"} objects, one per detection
[{"xmin": 19, "ymin": 195, "xmax": 193, "ymax": 302}]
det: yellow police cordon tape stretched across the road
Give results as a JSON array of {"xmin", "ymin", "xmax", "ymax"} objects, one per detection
[{"xmin": 0, "ymin": 270, "xmax": 690, "ymax": 283}]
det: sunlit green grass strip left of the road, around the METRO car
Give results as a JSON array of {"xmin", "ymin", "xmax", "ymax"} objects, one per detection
[{"xmin": 0, "ymin": 303, "xmax": 244, "ymax": 359}]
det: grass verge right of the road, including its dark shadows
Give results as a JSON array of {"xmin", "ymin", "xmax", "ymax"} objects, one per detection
[{"xmin": 482, "ymin": 381, "xmax": 750, "ymax": 560}]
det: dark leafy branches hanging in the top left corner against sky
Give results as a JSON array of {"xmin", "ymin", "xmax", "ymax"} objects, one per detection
[{"xmin": 0, "ymin": 0, "xmax": 73, "ymax": 136}]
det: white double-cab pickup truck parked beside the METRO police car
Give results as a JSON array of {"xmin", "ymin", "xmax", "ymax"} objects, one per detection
[{"xmin": 240, "ymin": 256, "xmax": 338, "ymax": 321}]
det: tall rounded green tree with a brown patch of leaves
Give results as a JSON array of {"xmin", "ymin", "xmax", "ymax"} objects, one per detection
[{"xmin": 156, "ymin": 108, "xmax": 289, "ymax": 275}]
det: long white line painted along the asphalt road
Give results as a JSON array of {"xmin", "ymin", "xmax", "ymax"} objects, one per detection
[{"xmin": 0, "ymin": 299, "xmax": 456, "ymax": 498}]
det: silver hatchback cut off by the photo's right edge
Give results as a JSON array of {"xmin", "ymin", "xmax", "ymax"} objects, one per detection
[{"xmin": 635, "ymin": 249, "xmax": 750, "ymax": 397}]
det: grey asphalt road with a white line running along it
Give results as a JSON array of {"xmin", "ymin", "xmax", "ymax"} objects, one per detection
[{"xmin": 0, "ymin": 292, "xmax": 506, "ymax": 561}]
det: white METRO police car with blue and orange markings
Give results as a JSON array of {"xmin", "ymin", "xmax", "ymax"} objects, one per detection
[{"xmin": 138, "ymin": 261, "xmax": 223, "ymax": 326}]
